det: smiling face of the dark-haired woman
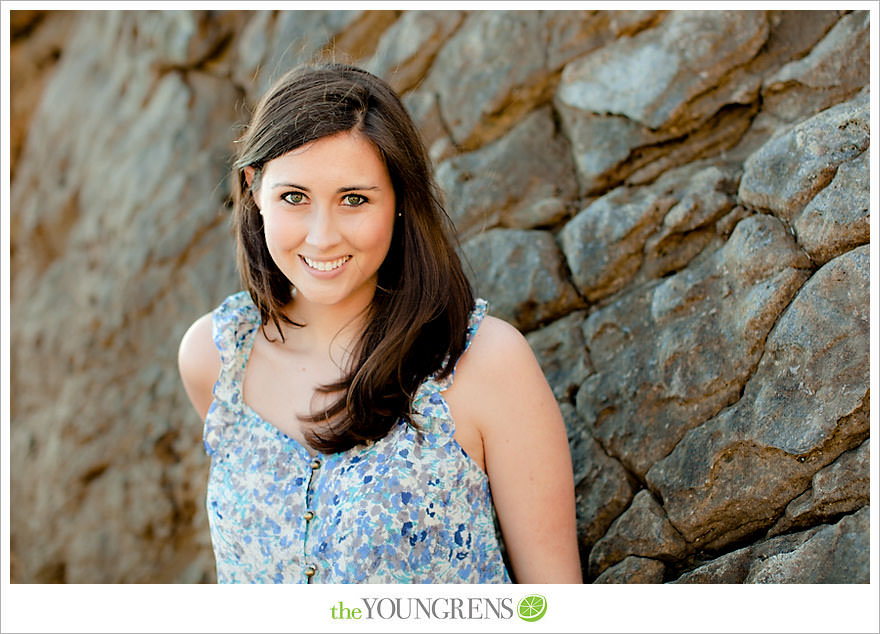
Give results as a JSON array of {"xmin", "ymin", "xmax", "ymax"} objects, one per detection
[{"xmin": 246, "ymin": 131, "xmax": 395, "ymax": 312}]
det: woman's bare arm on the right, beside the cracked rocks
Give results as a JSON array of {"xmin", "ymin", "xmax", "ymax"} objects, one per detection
[{"xmin": 455, "ymin": 317, "xmax": 582, "ymax": 583}]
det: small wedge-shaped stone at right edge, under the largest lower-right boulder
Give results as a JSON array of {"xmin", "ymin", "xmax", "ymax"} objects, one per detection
[{"xmin": 767, "ymin": 440, "xmax": 871, "ymax": 536}]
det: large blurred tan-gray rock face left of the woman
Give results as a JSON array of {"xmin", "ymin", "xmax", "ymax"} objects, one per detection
[{"xmin": 10, "ymin": 12, "xmax": 240, "ymax": 583}]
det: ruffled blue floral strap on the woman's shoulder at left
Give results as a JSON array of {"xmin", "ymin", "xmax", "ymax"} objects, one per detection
[{"xmin": 203, "ymin": 291, "xmax": 260, "ymax": 456}]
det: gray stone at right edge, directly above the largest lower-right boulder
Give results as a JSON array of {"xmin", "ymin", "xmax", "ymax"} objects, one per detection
[{"xmin": 794, "ymin": 150, "xmax": 871, "ymax": 265}]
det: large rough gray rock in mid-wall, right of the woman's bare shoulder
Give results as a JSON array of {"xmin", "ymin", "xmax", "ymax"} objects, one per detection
[{"xmin": 577, "ymin": 215, "xmax": 810, "ymax": 476}]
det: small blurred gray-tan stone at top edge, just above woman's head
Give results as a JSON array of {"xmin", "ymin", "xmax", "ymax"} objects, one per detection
[{"xmin": 364, "ymin": 11, "xmax": 464, "ymax": 94}]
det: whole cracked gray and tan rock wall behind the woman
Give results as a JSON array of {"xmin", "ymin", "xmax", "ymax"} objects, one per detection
[{"xmin": 10, "ymin": 11, "xmax": 870, "ymax": 583}]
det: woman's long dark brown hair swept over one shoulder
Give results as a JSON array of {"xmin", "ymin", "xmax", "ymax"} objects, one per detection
[{"xmin": 232, "ymin": 64, "xmax": 474, "ymax": 451}]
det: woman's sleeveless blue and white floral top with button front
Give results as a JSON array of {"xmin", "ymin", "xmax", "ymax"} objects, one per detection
[{"xmin": 204, "ymin": 292, "xmax": 510, "ymax": 583}]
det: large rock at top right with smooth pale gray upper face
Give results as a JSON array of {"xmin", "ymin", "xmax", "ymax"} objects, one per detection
[{"xmin": 555, "ymin": 11, "xmax": 769, "ymax": 193}]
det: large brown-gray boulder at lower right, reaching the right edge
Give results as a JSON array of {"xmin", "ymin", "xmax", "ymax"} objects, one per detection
[{"xmin": 648, "ymin": 247, "xmax": 869, "ymax": 549}]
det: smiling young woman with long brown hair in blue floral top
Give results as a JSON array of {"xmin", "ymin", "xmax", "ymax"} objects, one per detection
[{"xmin": 179, "ymin": 65, "xmax": 581, "ymax": 583}]
